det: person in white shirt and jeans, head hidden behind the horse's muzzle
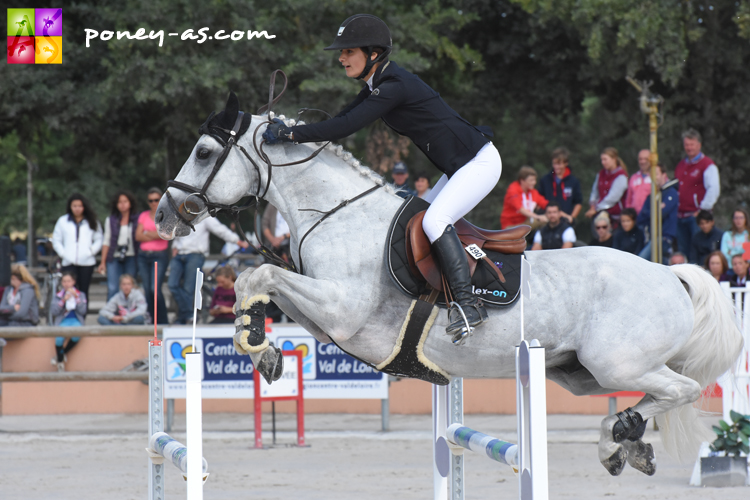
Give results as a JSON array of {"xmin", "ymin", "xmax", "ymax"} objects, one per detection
[{"xmin": 168, "ymin": 217, "xmax": 248, "ymax": 324}]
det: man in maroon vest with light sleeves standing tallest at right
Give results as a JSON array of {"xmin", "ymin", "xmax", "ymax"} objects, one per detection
[{"xmin": 674, "ymin": 128, "xmax": 720, "ymax": 254}]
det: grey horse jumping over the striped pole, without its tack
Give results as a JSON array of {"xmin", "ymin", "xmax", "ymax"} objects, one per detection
[{"xmin": 156, "ymin": 104, "xmax": 742, "ymax": 475}]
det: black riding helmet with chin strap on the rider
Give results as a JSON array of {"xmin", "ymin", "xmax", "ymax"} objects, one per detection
[{"xmin": 325, "ymin": 14, "xmax": 393, "ymax": 80}]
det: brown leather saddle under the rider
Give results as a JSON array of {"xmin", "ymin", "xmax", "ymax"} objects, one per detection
[{"xmin": 405, "ymin": 210, "xmax": 531, "ymax": 292}]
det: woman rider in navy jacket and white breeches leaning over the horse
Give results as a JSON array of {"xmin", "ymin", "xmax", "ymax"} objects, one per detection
[{"xmin": 263, "ymin": 14, "xmax": 502, "ymax": 335}]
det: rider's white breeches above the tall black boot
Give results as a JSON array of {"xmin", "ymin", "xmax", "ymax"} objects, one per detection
[{"xmin": 422, "ymin": 142, "xmax": 503, "ymax": 243}]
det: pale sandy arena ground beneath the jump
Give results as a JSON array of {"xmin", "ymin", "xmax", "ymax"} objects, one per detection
[{"xmin": 0, "ymin": 414, "xmax": 750, "ymax": 500}]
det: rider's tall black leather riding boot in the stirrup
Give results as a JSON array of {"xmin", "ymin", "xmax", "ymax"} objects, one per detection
[{"xmin": 432, "ymin": 226, "xmax": 488, "ymax": 344}]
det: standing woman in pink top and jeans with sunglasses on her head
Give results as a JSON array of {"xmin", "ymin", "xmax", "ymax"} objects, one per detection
[{"xmin": 137, "ymin": 188, "xmax": 169, "ymax": 324}]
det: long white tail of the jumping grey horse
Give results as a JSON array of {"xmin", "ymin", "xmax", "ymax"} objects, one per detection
[{"xmin": 656, "ymin": 264, "xmax": 743, "ymax": 460}]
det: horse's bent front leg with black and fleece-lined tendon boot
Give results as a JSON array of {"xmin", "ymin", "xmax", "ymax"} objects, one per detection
[{"xmin": 234, "ymin": 264, "xmax": 366, "ymax": 383}]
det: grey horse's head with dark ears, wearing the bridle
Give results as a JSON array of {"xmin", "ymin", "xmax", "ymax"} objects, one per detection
[{"xmin": 155, "ymin": 93, "xmax": 263, "ymax": 240}]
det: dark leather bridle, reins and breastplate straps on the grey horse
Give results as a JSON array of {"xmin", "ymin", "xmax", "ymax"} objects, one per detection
[{"xmin": 165, "ymin": 69, "xmax": 384, "ymax": 274}]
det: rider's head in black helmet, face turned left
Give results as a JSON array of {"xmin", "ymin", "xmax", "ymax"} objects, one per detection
[{"xmin": 325, "ymin": 14, "xmax": 393, "ymax": 80}]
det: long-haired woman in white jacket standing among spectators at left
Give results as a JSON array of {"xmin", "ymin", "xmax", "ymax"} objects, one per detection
[{"xmin": 52, "ymin": 193, "xmax": 102, "ymax": 308}]
